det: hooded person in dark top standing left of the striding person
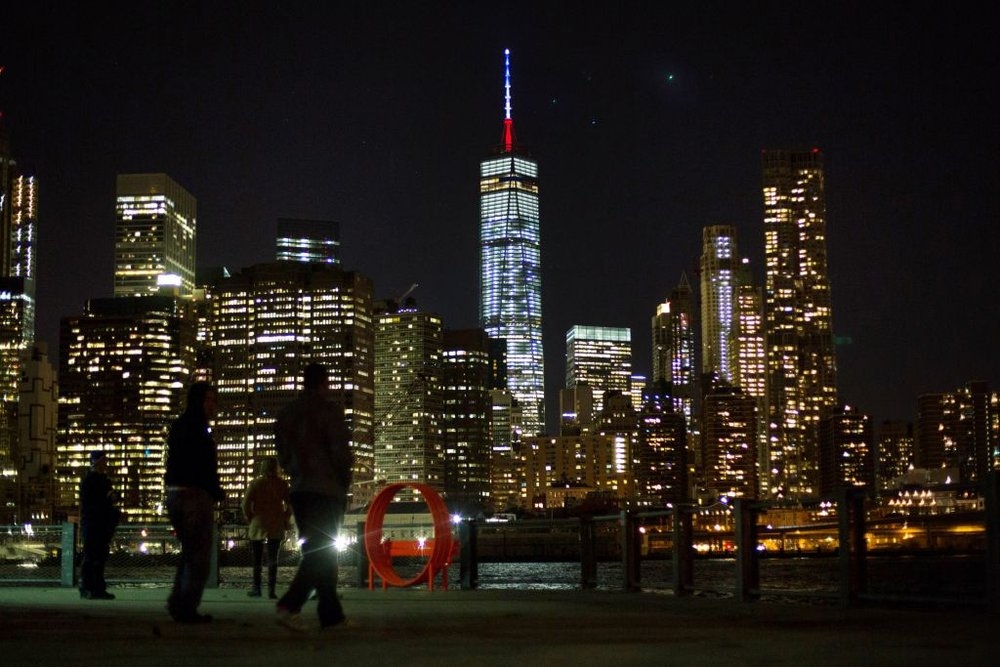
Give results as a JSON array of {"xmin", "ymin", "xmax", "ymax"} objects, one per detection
[{"xmin": 164, "ymin": 382, "xmax": 225, "ymax": 623}]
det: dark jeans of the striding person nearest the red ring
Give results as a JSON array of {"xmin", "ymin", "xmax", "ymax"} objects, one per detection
[{"xmin": 278, "ymin": 493, "xmax": 346, "ymax": 627}]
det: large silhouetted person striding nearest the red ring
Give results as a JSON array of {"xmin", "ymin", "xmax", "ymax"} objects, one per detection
[{"xmin": 275, "ymin": 363, "xmax": 354, "ymax": 631}]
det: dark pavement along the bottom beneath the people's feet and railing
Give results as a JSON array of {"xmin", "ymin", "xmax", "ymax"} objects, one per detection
[{"xmin": 0, "ymin": 586, "xmax": 1000, "ymax": 667}]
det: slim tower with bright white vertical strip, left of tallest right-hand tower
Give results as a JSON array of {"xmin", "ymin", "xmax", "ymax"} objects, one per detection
[{"xmin": 700, "ymin": 225, "xmax": 739, "ymax": 382}]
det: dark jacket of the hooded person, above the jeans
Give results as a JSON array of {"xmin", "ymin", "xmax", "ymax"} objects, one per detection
[{"xmin": 163, "ymin": 410, "xmax": 226, "ymax": 501}]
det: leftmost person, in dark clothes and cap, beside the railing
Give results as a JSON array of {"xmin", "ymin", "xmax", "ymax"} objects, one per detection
[{"xmin": 80, "ymin": 451, "xmax": 121, "ymax": 600}]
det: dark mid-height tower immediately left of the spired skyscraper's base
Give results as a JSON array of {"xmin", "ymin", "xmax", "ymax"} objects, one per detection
[{"xmin": 441, "ymin": 329, "xmax": 493, "ymax": 510}]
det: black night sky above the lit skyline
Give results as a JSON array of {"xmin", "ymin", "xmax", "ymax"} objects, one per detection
[{"xmin": 0, "ymin": 1, "xmax": 1000, "ymax": 434}]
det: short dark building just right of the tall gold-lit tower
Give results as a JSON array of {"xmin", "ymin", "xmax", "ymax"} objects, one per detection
[{"xmin": 819, "ymin": 405, "xmax": 875, "ymax": 494}]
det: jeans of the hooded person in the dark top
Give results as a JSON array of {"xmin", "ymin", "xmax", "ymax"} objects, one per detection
[{"xmin": 167, "ymin": 487, "xmax": 215, "ymax": 617}]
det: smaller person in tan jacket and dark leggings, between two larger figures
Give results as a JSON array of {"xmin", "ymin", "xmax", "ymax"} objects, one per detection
[{"xmin": 243, "ymin": 456, "xmax": 292, "ymax": 600}]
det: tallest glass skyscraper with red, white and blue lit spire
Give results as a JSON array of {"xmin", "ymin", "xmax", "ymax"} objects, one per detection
[{"xmin": 479, "ymin": 50, "xmax": 545, "ymax": 433}]
